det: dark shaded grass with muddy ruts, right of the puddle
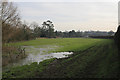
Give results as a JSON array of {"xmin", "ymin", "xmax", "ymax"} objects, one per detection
[{"xmin": 40, "ymin": 40, "xmax": 120, "ymax": 78}]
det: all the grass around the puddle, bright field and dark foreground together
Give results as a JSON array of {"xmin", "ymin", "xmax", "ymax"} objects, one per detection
[{"xmin": 3, "ymin": 38, "xmax": 119, "ymax": 78}]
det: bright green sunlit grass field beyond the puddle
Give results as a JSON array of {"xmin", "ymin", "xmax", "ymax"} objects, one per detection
[{"xmin": 9, "ymin": 38, "xmax": 106, "ymax": 52}]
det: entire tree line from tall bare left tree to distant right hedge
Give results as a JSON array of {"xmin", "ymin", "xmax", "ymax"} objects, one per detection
[{"xmin": 0, "ymin": 2, "xmax": 114, "ymax": 43}]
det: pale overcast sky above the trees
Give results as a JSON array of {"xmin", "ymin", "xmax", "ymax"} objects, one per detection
[{"xmin": 13, "ymin": 2, "xmax": 118, "ymax": 31}]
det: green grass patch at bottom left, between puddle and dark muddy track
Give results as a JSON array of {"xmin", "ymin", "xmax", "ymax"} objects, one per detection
[{"xmin": 2, "ymin": 58, "xmax": 55, "ymax": 78}]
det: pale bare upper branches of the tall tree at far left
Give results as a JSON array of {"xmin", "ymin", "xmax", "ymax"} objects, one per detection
[{"xmin": 1, "ymin": 2, "xmax": 20, "ymax": 27}]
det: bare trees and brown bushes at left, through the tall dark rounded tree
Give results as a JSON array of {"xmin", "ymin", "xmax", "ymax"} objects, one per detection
[{"xmin": 0, "ymin": 1, "xmax": 54, "ymax": 43}]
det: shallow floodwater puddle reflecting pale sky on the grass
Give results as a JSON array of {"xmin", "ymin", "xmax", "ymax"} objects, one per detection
[{"xmin": 5, "ymin": 46, "xmax": 73, "ymax": 71}]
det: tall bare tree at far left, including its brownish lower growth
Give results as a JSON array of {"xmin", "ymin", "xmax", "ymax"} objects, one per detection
[{"xmin": 0, "ymin": 1, "xmax": 21, "ymax": 42}]
